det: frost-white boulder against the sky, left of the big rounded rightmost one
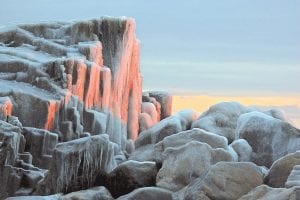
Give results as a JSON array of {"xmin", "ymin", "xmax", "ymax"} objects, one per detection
[{"xmin": 192, "ymin": 102, "xmax": 248, "ymax": 143}]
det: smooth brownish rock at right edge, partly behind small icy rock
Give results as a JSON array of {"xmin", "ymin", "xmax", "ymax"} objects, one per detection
[{"xmin": 265, "ymin": 151, "xmax": 300, "ymax": 188}]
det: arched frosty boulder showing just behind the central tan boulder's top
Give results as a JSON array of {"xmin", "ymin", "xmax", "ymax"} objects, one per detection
[{"xmin": 154, "ymin": 128, "xmax": 228, "ymax": 162}]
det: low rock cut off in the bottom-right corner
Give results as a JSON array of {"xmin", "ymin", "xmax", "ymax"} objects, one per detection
[{"xmin": 239, "ymin": 185, "xmax": 300, "ymax": 200}]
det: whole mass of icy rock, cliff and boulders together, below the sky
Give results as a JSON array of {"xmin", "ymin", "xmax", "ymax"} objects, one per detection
[{"xmin": 0, "ymin": 17, "xmax": 300, "ymax": 200}]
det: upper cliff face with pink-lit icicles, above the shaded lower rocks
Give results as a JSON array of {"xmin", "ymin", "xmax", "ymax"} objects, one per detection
[{"xmin": 0, "ymin": 18, "xmax": 142, "ymax": 145}]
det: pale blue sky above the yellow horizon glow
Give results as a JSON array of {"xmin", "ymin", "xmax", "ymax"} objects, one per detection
[{"xmin": 0, "ymin": 0, "xmax": 300, "ymax": 96}]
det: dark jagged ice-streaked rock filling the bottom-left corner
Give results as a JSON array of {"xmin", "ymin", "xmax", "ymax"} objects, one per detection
[{"xmin": 0, "ymin": 117, "xmax": 44, "ymax": 199}]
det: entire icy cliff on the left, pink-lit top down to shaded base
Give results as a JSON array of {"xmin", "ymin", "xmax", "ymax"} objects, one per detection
[{"xmin": 0, "ymin": 17, "xmax": 148, "ymax": 199}]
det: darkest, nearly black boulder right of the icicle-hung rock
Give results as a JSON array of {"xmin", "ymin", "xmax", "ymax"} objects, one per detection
[{"xmin": 106, "ymin": 160, "xmax": 158, "ymax": 198}]
